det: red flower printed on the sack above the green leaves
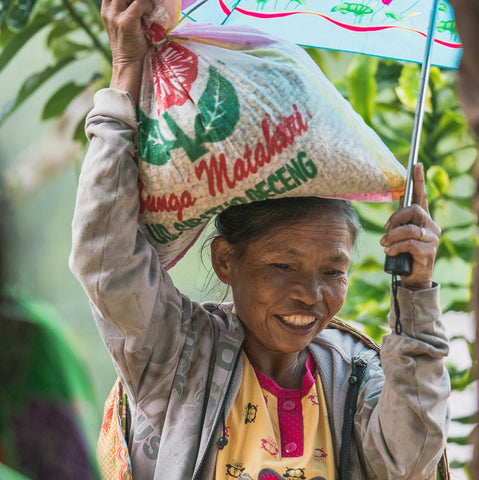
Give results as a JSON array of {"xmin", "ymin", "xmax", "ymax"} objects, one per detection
[{"xmin": 151, "ymin": 42, "xmax": 198, "ymax": 113}]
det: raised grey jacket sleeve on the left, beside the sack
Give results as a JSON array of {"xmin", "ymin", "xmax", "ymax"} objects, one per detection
[{"xmin": 70, "ymin": 89, "xmax": 185, "ymax": 401}]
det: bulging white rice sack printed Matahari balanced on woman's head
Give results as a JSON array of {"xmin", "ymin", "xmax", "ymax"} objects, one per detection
[{"xmin": 138, "ymin": 0, "xmax": 405, "ymax": 268}]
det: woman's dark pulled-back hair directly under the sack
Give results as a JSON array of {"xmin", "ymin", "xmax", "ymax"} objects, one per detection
[{"xmin": 215, "ymin": 197, "xmax": 361, "ymax": 250}]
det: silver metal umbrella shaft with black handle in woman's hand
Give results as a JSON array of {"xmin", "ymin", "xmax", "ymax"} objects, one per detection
[{"xmin": 384, "ymin": 0, "xmax": 439, "ymax": 275}]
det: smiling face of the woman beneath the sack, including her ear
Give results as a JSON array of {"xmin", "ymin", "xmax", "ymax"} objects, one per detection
[{"xmin": 213, "ymin": 210, "xmax": 352, "ymax": 354}]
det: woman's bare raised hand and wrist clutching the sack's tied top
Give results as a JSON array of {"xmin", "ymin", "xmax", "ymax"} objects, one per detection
[{"xmin": 101, "ymin": 0, "xmax": 153, "ymax": 103}]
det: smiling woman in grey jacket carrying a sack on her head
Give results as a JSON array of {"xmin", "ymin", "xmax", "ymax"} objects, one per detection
[{"xmin": 71, "ymin": 0, "xmax": 449, "ymax": 480}]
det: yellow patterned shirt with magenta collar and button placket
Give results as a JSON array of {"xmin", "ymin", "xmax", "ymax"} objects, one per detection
[{"xmin": 215, "ymin": 353, "xmax": 336, "ymax": 480}]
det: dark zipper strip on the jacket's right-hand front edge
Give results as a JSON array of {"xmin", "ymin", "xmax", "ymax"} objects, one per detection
[{"xmin": 339, "ymin": 357, "xmax": 368, "ymax": 480}]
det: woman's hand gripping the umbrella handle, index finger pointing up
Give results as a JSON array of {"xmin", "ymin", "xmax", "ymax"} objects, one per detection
[{"xmin": 381, "ymin": 164, "xmax": 441, "ymax": 290}]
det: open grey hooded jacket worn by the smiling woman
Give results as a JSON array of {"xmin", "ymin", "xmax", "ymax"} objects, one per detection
[{"xmin": 70, "ymin": 89, "xmax": 450, "ymax": 480}]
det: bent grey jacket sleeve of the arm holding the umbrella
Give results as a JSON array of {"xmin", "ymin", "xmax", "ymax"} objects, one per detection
[{"xmin": 355, "ymin": 285, "xmax": 450, "ymax": 480}]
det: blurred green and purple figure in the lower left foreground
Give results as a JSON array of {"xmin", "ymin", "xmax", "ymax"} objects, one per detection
[{"xmin": 0, "ymin": 189, "xmax": 98, "ymax": 480}]
